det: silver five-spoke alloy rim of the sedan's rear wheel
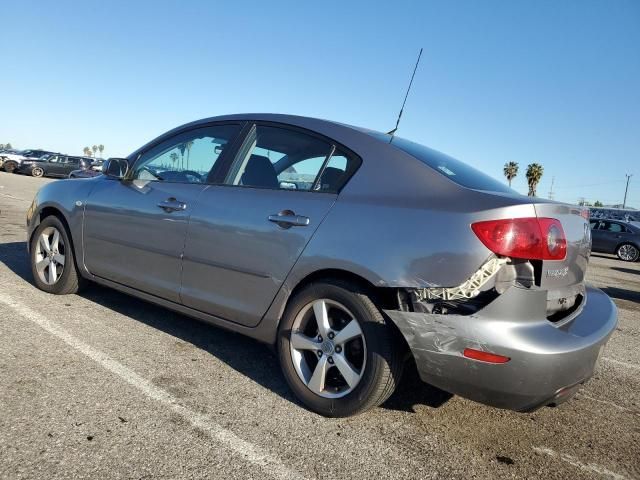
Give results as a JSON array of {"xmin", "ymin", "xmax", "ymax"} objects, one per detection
[{"xmin": 290, "ymin": 298, "xmax": 367, "ymax": 398}]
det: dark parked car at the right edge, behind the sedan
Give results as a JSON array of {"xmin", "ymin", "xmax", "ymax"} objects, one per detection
[{"xmin": 591, "ymin": 219, "xmax": 640, "ymax": 262}]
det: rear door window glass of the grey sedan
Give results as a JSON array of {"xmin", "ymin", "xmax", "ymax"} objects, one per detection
[{"xmin": 225, "ymin": 125, "xmax": 353, "ymax": 193}]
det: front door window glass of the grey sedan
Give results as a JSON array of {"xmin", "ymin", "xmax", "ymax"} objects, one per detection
[{"xmin": 132, "ymin": 125, "xmax": 239, "ymax": 183}]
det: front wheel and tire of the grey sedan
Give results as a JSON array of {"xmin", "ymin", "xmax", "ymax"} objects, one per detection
[{"xmin": 29, "ymin": 216, "xmax": 85, "ymax": 295}]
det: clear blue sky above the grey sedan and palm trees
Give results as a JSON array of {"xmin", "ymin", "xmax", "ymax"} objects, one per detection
[{"xmin": 0, "ymin": 0, "xmax": 640, "ymax": 208}]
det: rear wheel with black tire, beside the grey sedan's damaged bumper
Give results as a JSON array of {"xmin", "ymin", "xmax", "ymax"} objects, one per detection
[{"xmin": 277, "ymin": 280, "xmax": 404, "ymax": 417}]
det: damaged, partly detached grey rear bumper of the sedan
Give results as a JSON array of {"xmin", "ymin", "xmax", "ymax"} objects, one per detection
[{"xmin": 385, "ymin": 287, "xmax": 617, "ymax": 411}]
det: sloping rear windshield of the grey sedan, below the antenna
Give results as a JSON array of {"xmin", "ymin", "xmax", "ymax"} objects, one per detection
[{"xmin": 367, "ymin": 131, "xmax": 516, "ymax": 193}]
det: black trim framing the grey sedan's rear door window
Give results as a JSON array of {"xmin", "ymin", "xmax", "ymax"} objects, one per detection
[{"xmin": 216, "ymin": 120, "xmax": 363, "ymax": 195}]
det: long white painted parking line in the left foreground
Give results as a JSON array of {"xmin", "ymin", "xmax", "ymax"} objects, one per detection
[{"xmin": 0, "ymin": 293, "xmax": 303, "ymax": 479}]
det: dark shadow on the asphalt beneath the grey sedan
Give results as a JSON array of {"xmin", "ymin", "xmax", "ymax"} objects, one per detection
[{"xmin": 0, "ymin": 242, "xmax": 452, "ymax": 412}]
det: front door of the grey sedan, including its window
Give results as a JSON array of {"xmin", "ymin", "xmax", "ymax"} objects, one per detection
[{"xmin": 84, "ymin": 125, "xmax": 244, "ymax": 302}]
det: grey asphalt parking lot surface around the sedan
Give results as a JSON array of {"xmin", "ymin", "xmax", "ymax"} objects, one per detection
[{"xmin": 0, "ymin": 172, "xmax": 640, "ymax": 479}]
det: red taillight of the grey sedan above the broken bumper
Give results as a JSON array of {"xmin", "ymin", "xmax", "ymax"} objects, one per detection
[{"xmin": 471, "ymin": 217, "xmax": 567, "ymax": 260}]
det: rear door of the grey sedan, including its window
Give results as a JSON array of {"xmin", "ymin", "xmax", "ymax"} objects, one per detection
[{"xmin": 181, "ymin": 124, "xmax": 359, "ymax": 326}]
